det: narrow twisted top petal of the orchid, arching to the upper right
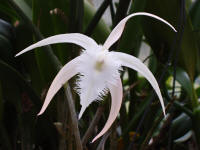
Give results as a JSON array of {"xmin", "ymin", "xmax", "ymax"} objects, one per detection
[{"xmin": 103, "ymin": 12, "xmax": 177, "ymax": 49}]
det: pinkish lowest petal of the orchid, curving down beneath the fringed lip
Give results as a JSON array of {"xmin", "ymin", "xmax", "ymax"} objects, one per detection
[{"xmin": 92, "ymin": 77, "xmax": 123, "ymax": 142}]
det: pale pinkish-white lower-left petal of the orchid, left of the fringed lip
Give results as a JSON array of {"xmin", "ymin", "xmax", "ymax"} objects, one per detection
[{"xmin": 38, "ymin": 56, "xmax": 80, "ymax": 115}]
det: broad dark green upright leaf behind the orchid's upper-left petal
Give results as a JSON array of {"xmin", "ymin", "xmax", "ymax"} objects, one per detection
[{"xmin": 33, "ymin": 0, "xmax": 70, "ymax": 86}]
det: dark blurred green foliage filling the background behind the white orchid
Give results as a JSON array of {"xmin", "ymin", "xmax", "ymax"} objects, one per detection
[{"xmin": 0, "ymin": 0, "xmax": 200, "ymax": 150}]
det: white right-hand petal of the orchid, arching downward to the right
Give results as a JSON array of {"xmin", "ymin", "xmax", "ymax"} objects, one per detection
[{"xmin": 112, "ymin": 52, "xmax": 166, "ymax": 116}]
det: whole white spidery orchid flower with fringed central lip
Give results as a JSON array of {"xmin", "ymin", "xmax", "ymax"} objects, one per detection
[{"xmin": 16, "ymin": 12, "xmax": 176, "ymax": 142}]
